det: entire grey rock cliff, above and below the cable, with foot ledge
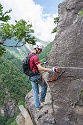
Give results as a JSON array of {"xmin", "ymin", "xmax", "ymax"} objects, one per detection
[{"xmin": 26, "ymin": 0, "xmax": 83, "ymax": 125}]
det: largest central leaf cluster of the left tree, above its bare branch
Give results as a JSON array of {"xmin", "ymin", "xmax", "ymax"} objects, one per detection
[{"xmin": 0, "ymin": 19, "xmax": 35, "ymax": 44}]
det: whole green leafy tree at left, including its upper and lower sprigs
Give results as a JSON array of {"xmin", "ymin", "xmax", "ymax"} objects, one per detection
[{"xmin": 0, "ymin": 4, "xmax": 36, "ymax": 56}]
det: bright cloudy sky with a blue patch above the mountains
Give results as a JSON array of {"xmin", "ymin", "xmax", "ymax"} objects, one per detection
[{"xmin": 0, "ymin": 0, "xmax": 63, "ymax": 41}]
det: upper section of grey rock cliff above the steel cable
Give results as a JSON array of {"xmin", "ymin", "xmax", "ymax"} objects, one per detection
[{"xmin": 50, "ymin": 0, "xmax": 83, "ymax": 67}]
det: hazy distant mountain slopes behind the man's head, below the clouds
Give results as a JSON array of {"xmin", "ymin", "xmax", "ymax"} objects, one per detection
[{"xmin": 5, "ymin": 38, "xmax": 49, "ymax": 60}]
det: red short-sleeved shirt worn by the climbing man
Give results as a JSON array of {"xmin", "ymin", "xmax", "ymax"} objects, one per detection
[{"xmin": 29, "ymin": 52, "xmax": 40, "ymax": 72}]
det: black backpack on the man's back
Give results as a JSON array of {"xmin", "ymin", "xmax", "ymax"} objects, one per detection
[{"xmin": 22, "ymin": 54, "xmax": 35, "ymax": 76}]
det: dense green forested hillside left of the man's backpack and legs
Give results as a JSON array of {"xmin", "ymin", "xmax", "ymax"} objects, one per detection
[{"xmin": 0, "ymin": 52, "xmax": 31, "ymax": 105}]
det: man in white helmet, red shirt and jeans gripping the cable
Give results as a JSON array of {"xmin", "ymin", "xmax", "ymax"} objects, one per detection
[{"xmin": 29, "ymin": 42, "xmax": 58, "ymax": 112}]
